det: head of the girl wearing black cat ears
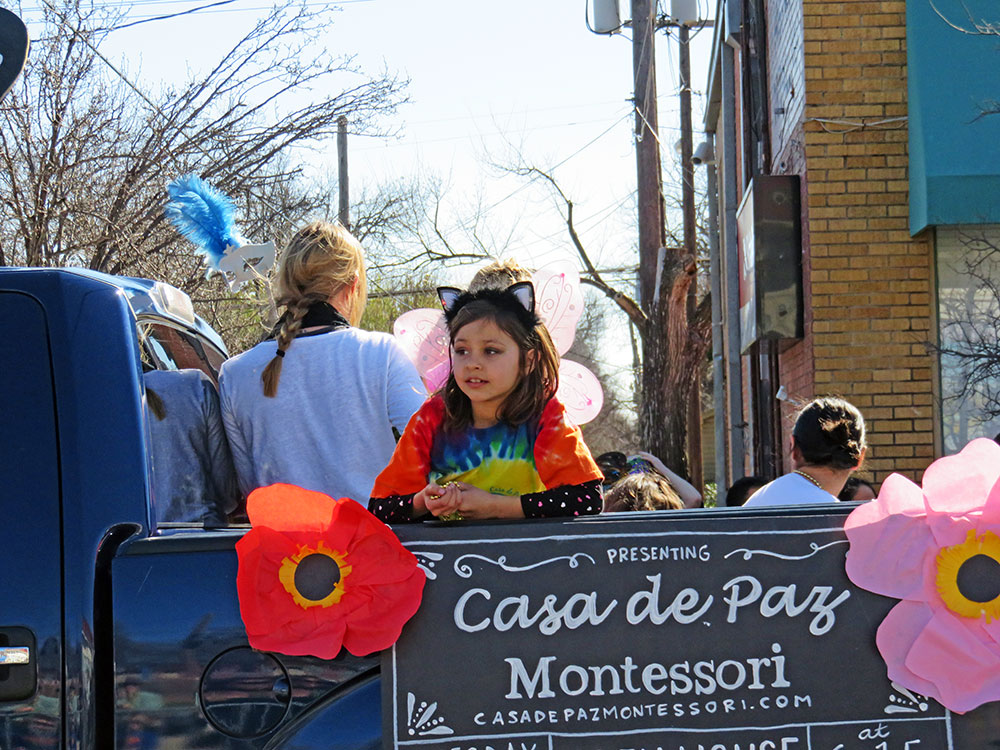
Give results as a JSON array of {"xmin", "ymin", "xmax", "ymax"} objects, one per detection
[{"xmin": 442, "ymin": 282, "xmax": 559, "ymax": 429}]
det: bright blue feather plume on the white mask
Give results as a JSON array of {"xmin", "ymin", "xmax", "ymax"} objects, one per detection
[{"xmin": 163, "ymin": 174, "xmax": 246, "ymax": 269}]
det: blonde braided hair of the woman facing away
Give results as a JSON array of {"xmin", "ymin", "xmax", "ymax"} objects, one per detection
[{"xmin": 260, "ymin": 221, "xmax": 368, "ymax": 398}]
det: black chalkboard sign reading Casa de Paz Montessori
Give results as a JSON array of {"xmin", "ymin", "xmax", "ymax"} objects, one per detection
[{"xmin": 382, "ymin": 508, "xmax": 1000, "ymax": 750}]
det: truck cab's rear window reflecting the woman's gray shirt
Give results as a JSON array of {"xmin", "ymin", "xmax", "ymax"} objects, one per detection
[{"xmin": 140, "ymin": 323, "xmax": 242, "ymax": 528}]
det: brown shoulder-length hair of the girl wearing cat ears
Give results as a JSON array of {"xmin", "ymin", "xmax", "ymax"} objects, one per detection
[{"xmin": 440, "ymin": 299, "xmax": 559, "ymax": 431}]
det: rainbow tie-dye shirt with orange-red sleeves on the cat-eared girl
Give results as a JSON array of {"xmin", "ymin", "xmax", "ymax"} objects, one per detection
[{"xmin": 372, "ymin": 396, "xmax": 603, "ymax": 498}]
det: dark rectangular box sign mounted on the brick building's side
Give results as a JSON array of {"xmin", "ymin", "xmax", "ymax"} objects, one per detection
[{"xmin": 736, "ymin": 175, "xmax": 802, "ymax": 351}]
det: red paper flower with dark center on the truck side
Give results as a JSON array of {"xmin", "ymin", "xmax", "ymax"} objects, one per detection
[{"xmin": 236, "ymin": 484, "xmax": 425, "ymax": 659}]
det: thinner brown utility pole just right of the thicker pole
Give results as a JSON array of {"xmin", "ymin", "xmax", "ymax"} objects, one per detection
[{"xmin": 677, "ymin": 19, "xmax": 705, "ymax": 492}]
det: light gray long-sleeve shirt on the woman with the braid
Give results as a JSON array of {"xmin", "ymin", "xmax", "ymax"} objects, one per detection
[{"xmin": 219, "ymin": 328, "xmax": 426, "ymax": 504}]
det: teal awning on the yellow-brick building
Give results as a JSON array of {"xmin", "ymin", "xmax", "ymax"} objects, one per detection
[{"xmin": 906, "ymin": 0, "xmax": 1000, "ymax": 234}]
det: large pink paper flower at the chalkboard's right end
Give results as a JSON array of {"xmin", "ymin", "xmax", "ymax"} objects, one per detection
[{"xmin": 844, "ymin": 439, "xmax": 1000, "ymax": 713}]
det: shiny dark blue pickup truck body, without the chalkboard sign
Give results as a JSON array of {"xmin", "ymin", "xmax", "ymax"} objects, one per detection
[{"xmin": 0, "ymin": 269, "xmax": 381, "ymax": 750}]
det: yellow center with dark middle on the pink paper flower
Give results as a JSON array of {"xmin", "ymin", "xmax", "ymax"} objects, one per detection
[{"xmin": 936, "ymin": 531, "xmax": 1000, "ymax": 622}]
